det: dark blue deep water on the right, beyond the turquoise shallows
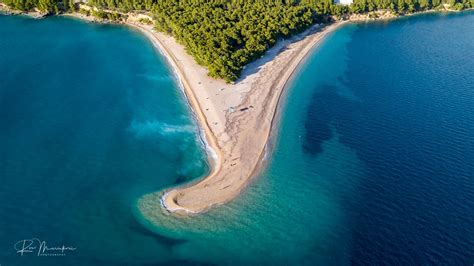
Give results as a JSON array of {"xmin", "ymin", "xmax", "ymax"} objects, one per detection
[{"xmin": 334, "ymin": 12, "xmax": 474, "ymax": 265}]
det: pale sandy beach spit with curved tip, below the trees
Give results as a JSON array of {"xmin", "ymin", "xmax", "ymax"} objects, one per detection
[{"xmin": 126, "ymin": 21, "xmax": 347, "ymax": 215}]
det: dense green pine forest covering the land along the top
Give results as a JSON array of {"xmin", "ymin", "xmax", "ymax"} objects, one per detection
[{"xmin": 0, "ymin": 0, "xmax": 474, "ymax": 81}]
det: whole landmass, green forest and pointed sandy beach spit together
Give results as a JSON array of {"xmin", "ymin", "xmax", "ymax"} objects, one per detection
[{"xmin": 0, "ymin": 0, "xmax": 474, "ymax": 215}]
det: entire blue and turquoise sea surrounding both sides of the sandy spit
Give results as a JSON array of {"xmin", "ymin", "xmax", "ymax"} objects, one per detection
[{"xmin": 0, "ymin": 11, "xmax": 474, "ymax": 265}]
